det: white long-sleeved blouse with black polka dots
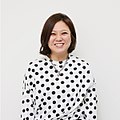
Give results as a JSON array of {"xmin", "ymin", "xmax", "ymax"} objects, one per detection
[{"xmin": 21, "ymin": 55, "xmax": 97, "ymax": 120}]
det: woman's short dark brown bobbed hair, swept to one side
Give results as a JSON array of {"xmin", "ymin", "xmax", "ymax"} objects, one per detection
[{"xmin": 40, "ymin": 13, "xmax": 76, "ymax": 56}]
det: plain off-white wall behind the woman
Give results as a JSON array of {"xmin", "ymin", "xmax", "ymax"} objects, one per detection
[{"xmin": 0, "ymin": 0, "xmax": 120, "ymax": 120}]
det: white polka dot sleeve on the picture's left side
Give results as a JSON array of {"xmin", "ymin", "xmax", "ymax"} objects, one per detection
[{"xmin": 21, "ymin": 64, "xmax": 35, "ymax": 120}]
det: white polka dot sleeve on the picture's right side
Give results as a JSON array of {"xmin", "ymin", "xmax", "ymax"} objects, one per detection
[{"xmin": 71, "ymin": 60, "xmax": 98, "ymax": 120}]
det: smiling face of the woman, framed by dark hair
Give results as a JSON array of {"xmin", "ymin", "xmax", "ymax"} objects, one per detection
[{"xmin": 48, "ymin": 21, "xmax": 71, "ymax": 55}]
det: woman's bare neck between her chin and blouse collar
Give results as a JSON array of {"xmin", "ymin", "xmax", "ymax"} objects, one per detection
[{"xmin": 50, "ymin": 53, "xmax": 68, "ymax": 61}]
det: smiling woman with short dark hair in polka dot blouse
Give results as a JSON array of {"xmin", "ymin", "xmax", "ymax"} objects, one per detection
[{"xmin": 21, "ymin": 13, "xmax": 97, "ymax": 120}]
